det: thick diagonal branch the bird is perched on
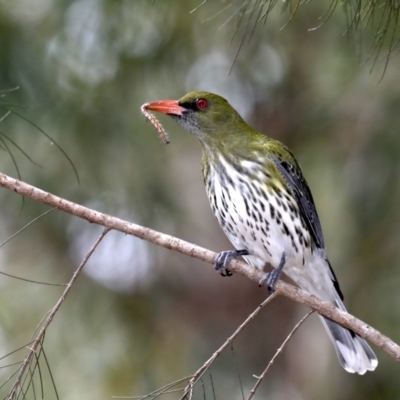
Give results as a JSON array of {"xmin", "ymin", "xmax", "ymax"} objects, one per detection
[{"xmin": 0, "ymin": 173, "xmax": 400, "ymax": 362}]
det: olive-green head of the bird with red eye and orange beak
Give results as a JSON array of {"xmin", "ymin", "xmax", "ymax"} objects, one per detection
[{"xmin": 144, "ymin": 91, "xmax": 252, "ymax": 147}]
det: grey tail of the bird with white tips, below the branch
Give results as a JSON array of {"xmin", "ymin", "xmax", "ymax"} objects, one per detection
[{"xmin": 319, "ymin": 298, "xmax": 378, "ymax": 375}]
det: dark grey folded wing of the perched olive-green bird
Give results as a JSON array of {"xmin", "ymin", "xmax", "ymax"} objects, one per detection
[{"xmin": 272, "ymin": 150, "xmax": 325, "ymax": 249}]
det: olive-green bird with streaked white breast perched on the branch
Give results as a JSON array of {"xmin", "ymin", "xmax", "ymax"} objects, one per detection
[{"xmin": 144, "ymin": 91, "xmax": 378, "ymax": 375}]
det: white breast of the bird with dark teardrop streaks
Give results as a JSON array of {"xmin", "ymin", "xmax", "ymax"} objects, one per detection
[{"xmin": 203, "ymin": 157, "xmax": 311, "ymax": 268}]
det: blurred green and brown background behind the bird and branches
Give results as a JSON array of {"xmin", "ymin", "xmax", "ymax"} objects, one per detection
[{"xmin": 0, "ymin": 0, "xmax": 400, "ymax": 400}]
